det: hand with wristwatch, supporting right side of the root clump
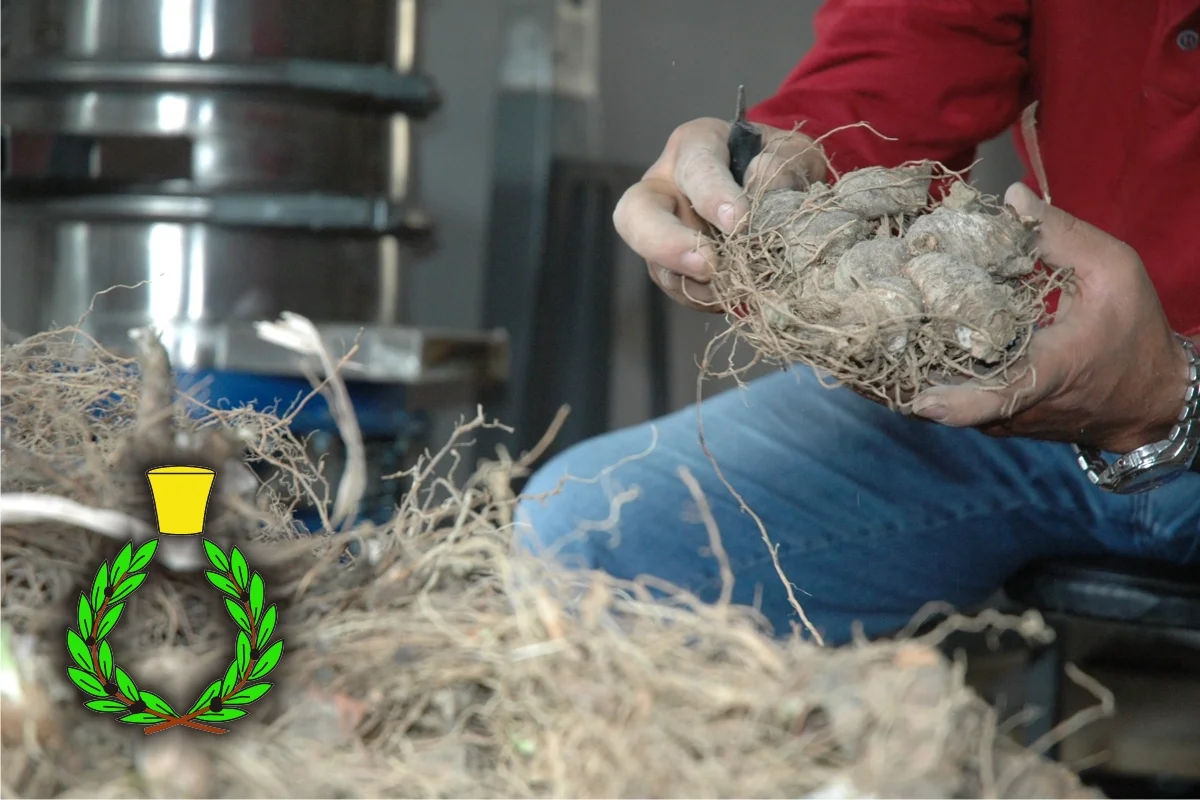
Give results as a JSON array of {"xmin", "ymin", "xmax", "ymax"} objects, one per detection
[{"xmin": 913, "ymin": 184, "xmax": 1187, "ymax": 453}]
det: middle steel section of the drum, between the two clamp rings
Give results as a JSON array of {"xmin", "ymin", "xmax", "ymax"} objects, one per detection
[{"xmin": 4, "ymin": 90, "xmax": 429, "ymax": 194}]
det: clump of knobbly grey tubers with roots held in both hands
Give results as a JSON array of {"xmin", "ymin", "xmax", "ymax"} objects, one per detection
[{"xmin": 714, "ymin": 155, "xmax": 1068, "ymax": 408}]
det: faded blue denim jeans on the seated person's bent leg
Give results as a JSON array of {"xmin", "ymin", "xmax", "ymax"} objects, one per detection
[{"xmin": 518, "ymin": 369, "xmax": 1200, "ymax": 643}]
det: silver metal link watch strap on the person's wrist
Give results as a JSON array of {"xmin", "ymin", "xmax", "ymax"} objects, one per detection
[{"xmin": 1072, "ymin": 333, "xmax": 1200, "ymax": 493}]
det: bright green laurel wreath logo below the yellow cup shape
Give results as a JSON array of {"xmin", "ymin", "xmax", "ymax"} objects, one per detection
[{"xmin": 67, "ymin": 540, "xmax": 283, "ymax": 735}]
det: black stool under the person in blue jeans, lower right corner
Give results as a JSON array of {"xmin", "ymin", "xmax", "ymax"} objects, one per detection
[{"xmin": 1004, "ymin": 558, "xmax": 1200, "ymax": 767}]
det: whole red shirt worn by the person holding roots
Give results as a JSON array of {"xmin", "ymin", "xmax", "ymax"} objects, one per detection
[{"xmin": 750, "ymin": 0, "xmax": 1200, "ymax": 336}]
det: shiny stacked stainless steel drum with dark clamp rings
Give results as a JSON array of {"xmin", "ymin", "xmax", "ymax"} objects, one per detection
[{"xmin": 0, "ymin": 0, "xmax": 437, "ymax": 347}]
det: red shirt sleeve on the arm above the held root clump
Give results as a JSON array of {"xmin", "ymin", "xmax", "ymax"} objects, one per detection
[{"xmin": 749, "ymin": 0, "xmax": 1030, "ymax": 173}]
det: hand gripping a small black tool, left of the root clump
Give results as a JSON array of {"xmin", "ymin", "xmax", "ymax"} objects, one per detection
[{"xmin": 612, "ymin": 118, "xmax": 826, "ymax": 313}]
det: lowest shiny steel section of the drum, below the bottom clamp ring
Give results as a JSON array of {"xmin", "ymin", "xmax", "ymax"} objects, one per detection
[{"xmin": 0, "ymin": 214, "xmax": 412, "ymax": 335}]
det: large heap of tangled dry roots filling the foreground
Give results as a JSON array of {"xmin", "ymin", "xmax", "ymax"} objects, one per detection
[{"xmin": 0, "ymin": 331, "xmax": 1091, "ymax": 798}]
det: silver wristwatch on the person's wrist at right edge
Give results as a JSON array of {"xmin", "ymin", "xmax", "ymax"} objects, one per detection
[{"xmin": 1072, "ymin": 333, "xmax": 1200, "ymax": 494}]
